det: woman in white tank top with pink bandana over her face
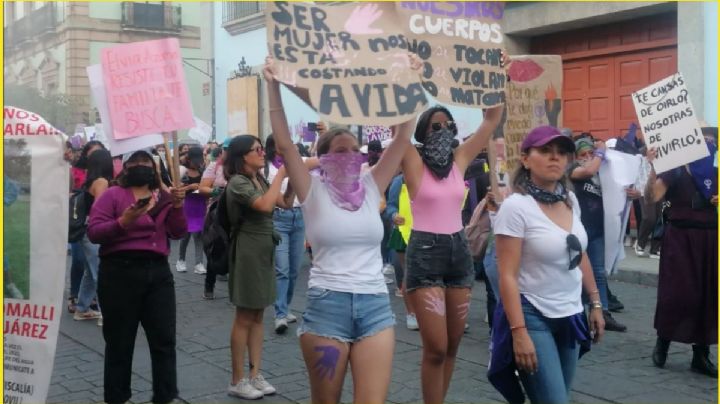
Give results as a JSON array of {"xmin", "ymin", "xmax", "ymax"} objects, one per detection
[{"xmin": 263, "ymin": 58, "xmax": 419, "ymax": 403}]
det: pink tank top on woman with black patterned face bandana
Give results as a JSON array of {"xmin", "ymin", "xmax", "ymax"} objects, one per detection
[{"xmin": 410, "ymin": 163, "xmax": 465, "ymax": 234}]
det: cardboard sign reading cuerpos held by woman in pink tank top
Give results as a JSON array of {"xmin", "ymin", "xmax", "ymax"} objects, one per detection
[{"xmin": 397, "ymin": 1, "xmax": 506, "ymax": 108}]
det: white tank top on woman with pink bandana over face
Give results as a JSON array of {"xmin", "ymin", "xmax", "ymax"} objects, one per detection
[{"xmin": 302, "ymin": 173, "xmax": 387, "ymax": 294}]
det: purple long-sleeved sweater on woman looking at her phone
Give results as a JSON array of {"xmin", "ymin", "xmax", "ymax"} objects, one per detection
[{"xmin": 87, "ymin": 186, "xmax": 187, "ymax": 256}]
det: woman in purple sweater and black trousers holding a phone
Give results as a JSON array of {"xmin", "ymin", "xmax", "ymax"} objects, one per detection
[{"xmin": 88, "ymin": 150, "xmax": 187, "ymax": 403}]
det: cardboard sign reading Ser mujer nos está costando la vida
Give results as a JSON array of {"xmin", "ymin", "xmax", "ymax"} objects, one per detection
[{"xmin": 265, "ymin": 2, "xmax": 427, "ymax": 126}]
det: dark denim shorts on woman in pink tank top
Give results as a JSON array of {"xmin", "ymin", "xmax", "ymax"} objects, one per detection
[{"xmin": 405, "ymin": 230, "xmax": 475, "ymax": 291}]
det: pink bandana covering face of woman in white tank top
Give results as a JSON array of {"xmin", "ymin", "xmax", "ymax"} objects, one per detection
[{"xmin": 320, "ymin": 152, "xmax": 365, "ymax": 211}]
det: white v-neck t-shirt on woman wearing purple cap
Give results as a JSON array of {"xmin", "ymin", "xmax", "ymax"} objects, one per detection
[{"xmin": 493, "ymin": 192, "xmax": 587, "ymax": 318}]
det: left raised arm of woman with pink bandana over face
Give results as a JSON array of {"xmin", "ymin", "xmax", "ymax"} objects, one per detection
[{"xmin": 263, "ymin": 56, "xmax": 311, "ymax": 202}]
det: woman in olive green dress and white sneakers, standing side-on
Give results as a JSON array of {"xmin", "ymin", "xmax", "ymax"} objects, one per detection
[{"xmin": 221, "ymin": 135, "xmax": 285, "ymax": 399}]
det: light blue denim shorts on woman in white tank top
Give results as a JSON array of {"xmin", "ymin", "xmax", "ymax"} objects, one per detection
[{"xmin": 297, "ymin": 288, "xmax": 395, "ymax": 343}]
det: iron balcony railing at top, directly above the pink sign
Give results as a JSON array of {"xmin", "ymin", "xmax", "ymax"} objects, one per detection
[{"xmin": 120, "ymin": 1, "xmax": 182, "ymax": 31}]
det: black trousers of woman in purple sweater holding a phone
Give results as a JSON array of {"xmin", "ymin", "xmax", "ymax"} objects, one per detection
[{"xmin": 97, "ymin": 251, "xmax": 178, "ymax": 403}]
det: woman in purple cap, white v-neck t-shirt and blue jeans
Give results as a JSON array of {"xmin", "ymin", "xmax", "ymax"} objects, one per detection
[{"xmin": 489, "ymin": 126, "xmax": 605, "ymax": 403}]
